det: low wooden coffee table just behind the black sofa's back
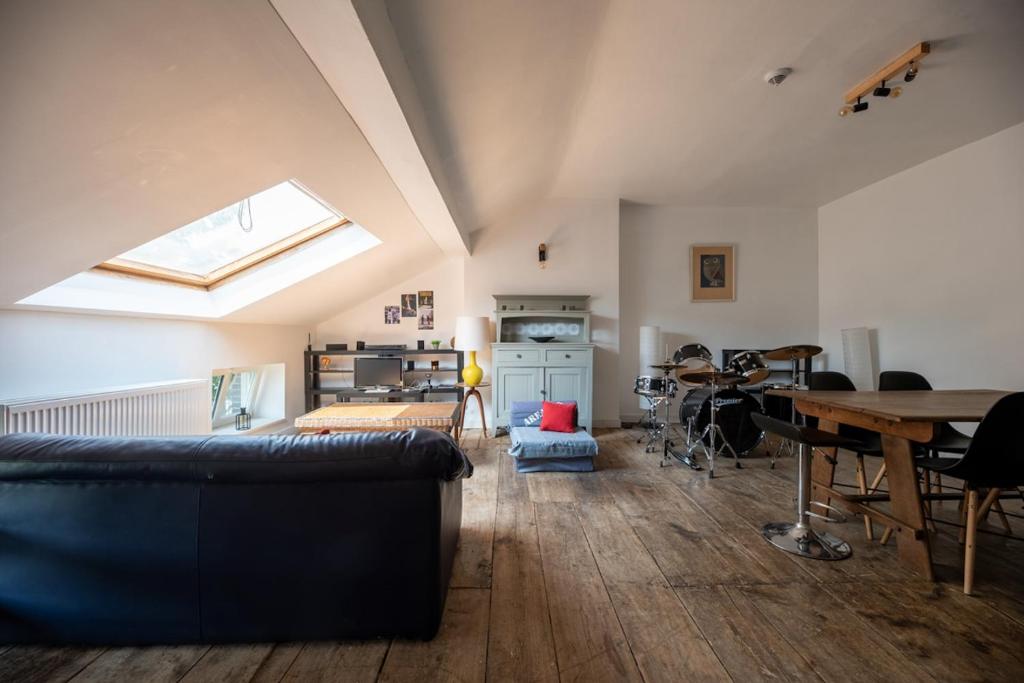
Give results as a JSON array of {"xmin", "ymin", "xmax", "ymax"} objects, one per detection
[{"xmin": 295, "ymin": 401, "xmax": 459, "ymax": 434}]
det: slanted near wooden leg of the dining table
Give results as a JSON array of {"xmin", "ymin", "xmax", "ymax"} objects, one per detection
[{"xmin": 882, "ymin": 434, "xmax": 935, "ymax": 581}]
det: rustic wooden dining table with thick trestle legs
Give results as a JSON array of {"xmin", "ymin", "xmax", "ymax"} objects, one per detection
[{"xmin": 768, "ymin": 389, "xmax": 1009, "ymax": 581}]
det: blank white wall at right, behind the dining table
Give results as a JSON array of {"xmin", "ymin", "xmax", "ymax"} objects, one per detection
[{"xmin": 818, "ymin": 124, "xmax": 1024, "ymax": 390}]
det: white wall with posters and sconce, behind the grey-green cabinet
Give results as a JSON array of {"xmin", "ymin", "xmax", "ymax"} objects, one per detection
[{"xmin": 316, "ymin": 200, "xmax": 618, "ymax": 426}]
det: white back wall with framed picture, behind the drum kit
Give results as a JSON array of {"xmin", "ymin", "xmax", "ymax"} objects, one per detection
[{"xmin": 618, "ymin": 202, "xmax": 818, "ymax": 420}]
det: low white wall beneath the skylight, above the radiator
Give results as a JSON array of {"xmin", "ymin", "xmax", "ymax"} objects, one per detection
[{"xmin": 0, "ymin": 310, "xmax": 307, "ymax": 421}]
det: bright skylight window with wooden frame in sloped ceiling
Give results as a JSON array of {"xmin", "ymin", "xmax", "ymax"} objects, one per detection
[{"xmin": 97, "ymin": 180, "xmax": 348, "ymax": 288}]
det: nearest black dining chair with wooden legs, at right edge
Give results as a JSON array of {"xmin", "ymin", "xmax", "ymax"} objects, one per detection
[{"xmin": 915, "ymin": 391, "xmax": 1024, "ymax": 595}]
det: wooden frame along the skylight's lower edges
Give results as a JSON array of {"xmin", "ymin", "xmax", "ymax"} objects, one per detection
[{"xmin": 93, "ymin": 216, "xmax": 352, "ymax": 290}]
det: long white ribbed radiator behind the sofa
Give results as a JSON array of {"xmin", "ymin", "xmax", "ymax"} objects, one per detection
[{"xmin": 0, "ymin": 380, "xmax": 210, "ymax": 436}]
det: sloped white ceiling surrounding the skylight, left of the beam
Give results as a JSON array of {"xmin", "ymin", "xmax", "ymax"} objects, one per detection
[{"xmin": 0, "ymin": 0, "xmax": 454, "ymax": 324}]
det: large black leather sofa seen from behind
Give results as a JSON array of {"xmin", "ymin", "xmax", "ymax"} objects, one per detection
[{"xmin": 0, "ymin": 430, "xmax": 472, "ymax": 644}]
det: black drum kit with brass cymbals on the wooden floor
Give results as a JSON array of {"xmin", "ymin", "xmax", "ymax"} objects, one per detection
[{"xmin": 633, "ymin": 344, "xmax": 821, "ymax": 477}]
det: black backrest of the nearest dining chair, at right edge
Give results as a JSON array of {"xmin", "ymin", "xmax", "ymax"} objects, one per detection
[{"xmin": 950, "ymin": 391, "xmax": 1024, "ymax": 488}]
